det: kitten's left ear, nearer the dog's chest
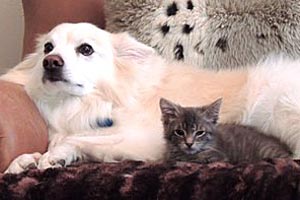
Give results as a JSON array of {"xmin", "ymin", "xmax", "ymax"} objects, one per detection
[{"xmin": 159, "ymin": 98, "xmax": 180, "ymax": 119}]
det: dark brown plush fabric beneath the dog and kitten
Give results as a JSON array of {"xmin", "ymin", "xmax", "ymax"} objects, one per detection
[{"xmin": 0, "ymin": 159, "xmax": 300, "ymax": 200}]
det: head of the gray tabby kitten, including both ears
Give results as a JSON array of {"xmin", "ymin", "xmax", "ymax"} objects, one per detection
[{"xmin": 160, "ymin": 98, "xmax": 222, "ymax": 154}]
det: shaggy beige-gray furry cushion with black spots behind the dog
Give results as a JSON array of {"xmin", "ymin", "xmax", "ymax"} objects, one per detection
[{"xmin": 105, "ymin": 0, "xmax": 300, "ymax": 69}]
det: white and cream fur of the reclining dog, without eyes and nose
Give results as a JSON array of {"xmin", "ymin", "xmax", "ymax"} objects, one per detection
[{"xmin": 2, "ymin": 23, "xmax": 300, "ymax": 173}]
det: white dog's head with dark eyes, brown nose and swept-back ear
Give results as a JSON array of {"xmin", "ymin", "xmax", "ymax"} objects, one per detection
[{"xmin": 26, "ymin": 23, "xmax": 154, "ymax": 96}]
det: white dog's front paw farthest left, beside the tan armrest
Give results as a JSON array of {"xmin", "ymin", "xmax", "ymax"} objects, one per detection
[{"xmin": 4, "ymin": 152, "xmax": 42, "ymax": 174}]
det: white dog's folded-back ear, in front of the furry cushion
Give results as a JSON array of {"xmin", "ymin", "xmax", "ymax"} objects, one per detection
[{"xmin": 112, "ymin": 33, "xmax": 155, "ymax": 61}]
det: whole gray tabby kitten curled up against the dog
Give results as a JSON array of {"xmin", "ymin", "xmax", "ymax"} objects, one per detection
[{"xmin": 160, "ymin": 98, "xmax": 292, "ymax": 164}]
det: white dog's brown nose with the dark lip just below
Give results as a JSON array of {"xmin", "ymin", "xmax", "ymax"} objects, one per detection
[{"xmin": 43, "ymin": 55, "xmax": 65, "ymax": 82}]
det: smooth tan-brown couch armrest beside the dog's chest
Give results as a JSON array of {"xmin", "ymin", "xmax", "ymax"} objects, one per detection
[{"xmin": 0, "ymin": 81, "xmax": 48, "ymax": 172}]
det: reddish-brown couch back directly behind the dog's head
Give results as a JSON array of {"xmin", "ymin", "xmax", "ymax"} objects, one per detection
[{"xmin": 22, "ymin": 0, "xmax": 105, "ymax": 56}]
